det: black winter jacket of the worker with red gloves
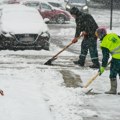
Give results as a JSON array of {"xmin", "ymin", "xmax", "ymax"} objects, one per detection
[{"xmin": 75, "ymin": 11, "xmax": 98, "ymax": 37}]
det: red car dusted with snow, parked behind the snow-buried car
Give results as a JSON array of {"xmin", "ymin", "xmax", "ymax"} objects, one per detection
[{"xmin": 21, "ymin": 0, "xmax": 71, "ymax": 24}]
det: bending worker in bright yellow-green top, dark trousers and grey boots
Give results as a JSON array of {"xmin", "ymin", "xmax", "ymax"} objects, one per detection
[{"xmin": 96, "ymin": 28, "xmax": 120, "ymax": 94}]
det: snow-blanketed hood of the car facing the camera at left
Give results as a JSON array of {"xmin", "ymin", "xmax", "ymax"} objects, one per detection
[{"xmin": 1, "ymin": 21, "xmax": 48, "ymax": 34}]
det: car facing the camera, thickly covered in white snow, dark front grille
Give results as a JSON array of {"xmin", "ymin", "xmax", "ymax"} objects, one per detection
[{"xmin": 0, "ymin": 4, "xmax": 50, "ymax": 50}]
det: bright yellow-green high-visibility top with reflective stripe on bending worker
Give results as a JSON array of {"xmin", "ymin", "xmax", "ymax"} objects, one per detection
[{"xmin": 100, "ymin": 33, "xmax": 120, "ymax": 59}]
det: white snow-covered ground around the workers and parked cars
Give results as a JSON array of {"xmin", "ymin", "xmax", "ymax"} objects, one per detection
[{"xmin": 0, "ymin": 2, "xmax": 120, "ymax": 120}]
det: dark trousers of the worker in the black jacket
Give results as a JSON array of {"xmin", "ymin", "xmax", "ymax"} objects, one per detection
[{"xmin": 79, "ymin": 37, "xmax": 99, "ymax": 65}]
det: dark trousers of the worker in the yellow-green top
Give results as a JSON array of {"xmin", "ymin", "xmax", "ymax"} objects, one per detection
[{"xmin": 109, "ymin": 58, "xmax": 120, "ymax": 78}]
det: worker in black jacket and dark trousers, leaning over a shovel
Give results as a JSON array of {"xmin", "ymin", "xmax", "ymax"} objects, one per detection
[{"xmin": 70, "ymin": 7, "xmax": 100, "ymax": 68}]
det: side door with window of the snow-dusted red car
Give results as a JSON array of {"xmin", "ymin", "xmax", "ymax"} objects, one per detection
[{"xmin": 40, "ymin": 3, "xmax": 54, "ymax": 19}]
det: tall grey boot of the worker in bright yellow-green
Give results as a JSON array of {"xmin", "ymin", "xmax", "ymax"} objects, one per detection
[{"xmin": 105, "ymin": 78, "xmax": 117, "ymax": 94}]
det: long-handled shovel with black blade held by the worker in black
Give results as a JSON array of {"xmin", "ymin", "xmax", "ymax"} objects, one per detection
[{"xmin": 44, "ymin": 35, "xmax": 82, "ymax": 65}]
